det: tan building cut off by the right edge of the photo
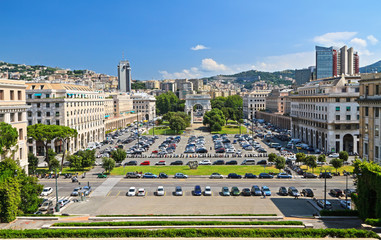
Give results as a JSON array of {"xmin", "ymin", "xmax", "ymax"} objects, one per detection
[{"xmin": 358, "ymin": 73, "xmax": 381, "ymax": 164}]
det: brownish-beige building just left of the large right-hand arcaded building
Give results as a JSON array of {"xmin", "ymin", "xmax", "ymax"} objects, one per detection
[{"xmin": 266, "ymin": 89, "xmax": 292, "ymax": 115}]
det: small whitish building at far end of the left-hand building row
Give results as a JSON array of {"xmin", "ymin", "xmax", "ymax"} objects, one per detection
[{"xmin": 131, "ymin": 93, "xmax": 156, "ymax": 121}]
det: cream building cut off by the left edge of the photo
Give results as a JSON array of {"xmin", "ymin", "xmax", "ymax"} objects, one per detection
[{"xmin": 0, "ymin": 79, "xmax": 28, "ymax": 172}]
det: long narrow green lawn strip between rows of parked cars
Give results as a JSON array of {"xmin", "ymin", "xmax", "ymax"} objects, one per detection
[{"xmin": 111, "ymin": 165, "xmax": 279, "ymax": 176}]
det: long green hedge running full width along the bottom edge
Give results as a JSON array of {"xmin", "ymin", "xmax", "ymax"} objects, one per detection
[{"xmin": 0, "ymin": 229, "xmax": 379, "ymax": 238}]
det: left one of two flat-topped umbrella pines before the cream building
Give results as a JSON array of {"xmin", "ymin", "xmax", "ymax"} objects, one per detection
[{"xmin": 28, "ymin": 123, "xmax": 61, "ymax": 168}]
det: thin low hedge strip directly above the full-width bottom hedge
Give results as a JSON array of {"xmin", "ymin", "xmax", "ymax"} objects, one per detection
[{"xmin": 53, "ymin": 221, "xmax": 303, "ymax": 227}]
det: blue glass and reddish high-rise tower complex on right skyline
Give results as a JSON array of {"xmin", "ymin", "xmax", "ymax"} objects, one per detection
[{"xmin": 315, "ymin": 46, "xmax": 360, "ymax": 79}]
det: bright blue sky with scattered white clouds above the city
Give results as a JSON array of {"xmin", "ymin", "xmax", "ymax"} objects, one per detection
[{"xmin": 0, "ymin": 0, "xmax": 381, "ymax": 80}]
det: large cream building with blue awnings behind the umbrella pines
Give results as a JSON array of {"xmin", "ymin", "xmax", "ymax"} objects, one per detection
[{"xmin": 26, "ymin": 83, "xmax": 105, "ymax": 155}]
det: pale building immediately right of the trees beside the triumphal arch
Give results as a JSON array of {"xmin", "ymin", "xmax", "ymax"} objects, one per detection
[{"xmin": 243, "ymin": 90, "xmax": 271, "ymax": 119}]
